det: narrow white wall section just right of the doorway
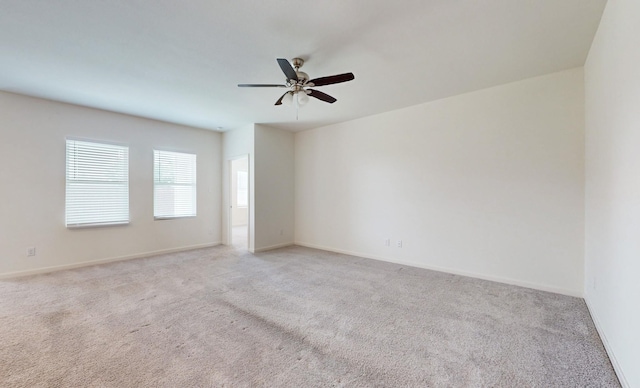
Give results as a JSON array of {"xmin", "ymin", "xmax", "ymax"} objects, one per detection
[{"xmin": 255, "ymin": 124, "xmax": 294, "ymax": 251}]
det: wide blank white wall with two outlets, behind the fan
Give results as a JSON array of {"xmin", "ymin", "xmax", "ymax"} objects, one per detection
[{"xmin": 295, "ymin": 69, "xmax": 584, "ymax": 295}]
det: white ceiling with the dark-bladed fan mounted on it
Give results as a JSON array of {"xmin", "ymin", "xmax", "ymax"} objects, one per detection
[{"xmin": 0, "ymin": 0, "xmax": 606, "ymax": 130}]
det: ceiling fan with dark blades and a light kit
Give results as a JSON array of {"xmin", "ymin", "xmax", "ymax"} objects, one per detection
[{"xmin": 238, "ymin": 58, "xmax": 355, "ymax": 107}]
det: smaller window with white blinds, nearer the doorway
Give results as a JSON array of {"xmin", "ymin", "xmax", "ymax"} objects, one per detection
[{"xmin": 153, "ymin": 150, "xmax": 196, "ymax": 219}]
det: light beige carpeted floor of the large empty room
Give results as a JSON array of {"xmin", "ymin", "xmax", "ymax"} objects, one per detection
[{"xmin": 0, "ymin": 247, "xmax": 619, "ymax": 387}]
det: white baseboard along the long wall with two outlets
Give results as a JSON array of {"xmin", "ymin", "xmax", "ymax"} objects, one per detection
[{"xmin": 295, "ymin": 241, "xmax": 584, "ymax": 298}]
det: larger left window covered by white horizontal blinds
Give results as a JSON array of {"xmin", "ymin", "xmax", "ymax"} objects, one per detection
[{"xmin": 65, "ymin": 139, "xmax": 129, "ymax": 227}]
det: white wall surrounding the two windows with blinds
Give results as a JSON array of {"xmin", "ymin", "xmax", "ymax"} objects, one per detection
[{"xmin": 0, "ymin": 92, "xmax": 221, "ymax": 275}]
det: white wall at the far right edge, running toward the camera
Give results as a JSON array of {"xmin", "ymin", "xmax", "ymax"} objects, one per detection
[{"xmin": 585, "ymin": 0, "xmax": 640, "ymax": 387}]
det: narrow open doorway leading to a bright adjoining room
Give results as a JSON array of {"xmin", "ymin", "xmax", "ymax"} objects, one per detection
[{"xmin": 229, "ymin": 156, "xmax": 249, "ymax": 249}]
